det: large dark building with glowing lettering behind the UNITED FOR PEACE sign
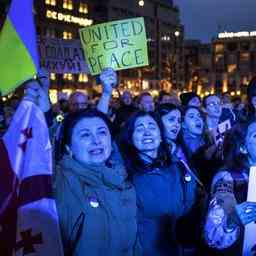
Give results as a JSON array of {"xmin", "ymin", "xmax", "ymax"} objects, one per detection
[{"xmin": 32, "ymin": 0, "xmax": 183, "ymax": 98}]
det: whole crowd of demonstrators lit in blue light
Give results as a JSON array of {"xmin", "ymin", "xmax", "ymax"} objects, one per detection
[{"xmin": 0, "ymin": 69, "xmax": 256, "ymax": 256}]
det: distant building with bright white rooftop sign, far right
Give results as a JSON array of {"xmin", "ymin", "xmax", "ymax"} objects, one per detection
[{"xmin": 212, "ymin": 31, "xmax": 256, "ymax": 95}]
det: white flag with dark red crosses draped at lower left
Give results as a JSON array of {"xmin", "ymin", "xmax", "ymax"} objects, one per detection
[{"xmin": 0, "ymin": 100, "xmax": 63, "ymax": 256}]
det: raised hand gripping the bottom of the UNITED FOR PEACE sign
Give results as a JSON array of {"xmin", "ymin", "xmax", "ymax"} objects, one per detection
[{"xmin": 100, "ymin": 68, "xmax": 117, "ymax": 95}]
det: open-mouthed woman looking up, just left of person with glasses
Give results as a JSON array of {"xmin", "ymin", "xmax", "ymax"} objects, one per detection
[{"xmin": 181, "ymin": 107, "xmax": 223, "ymax": 192}]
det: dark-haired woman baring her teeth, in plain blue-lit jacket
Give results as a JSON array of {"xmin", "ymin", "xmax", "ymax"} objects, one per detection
[{"xmin": 120, "ymin": 111, "xmax": 194, "ymax": 256}]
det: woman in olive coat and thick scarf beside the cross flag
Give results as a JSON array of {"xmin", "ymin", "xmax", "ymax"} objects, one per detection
[{"xmin": 54, "ymin": 110, "xmax": 137, "ymax": 256}]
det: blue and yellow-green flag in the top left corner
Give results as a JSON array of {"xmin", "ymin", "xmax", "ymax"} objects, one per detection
[{"xmin": 0, "ymin": 0, "xmax": 39, "ymax": 95}]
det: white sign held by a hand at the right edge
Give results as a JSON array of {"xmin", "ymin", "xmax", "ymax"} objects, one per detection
[{"xmin": 243, "ymin": 166, "xmax": 256, "ymax": 256}]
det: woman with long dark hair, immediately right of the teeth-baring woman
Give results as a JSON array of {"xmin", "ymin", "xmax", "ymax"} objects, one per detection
[{"xmin": 157, "ymin": 104, "xmax": 206, "ymax": 255}]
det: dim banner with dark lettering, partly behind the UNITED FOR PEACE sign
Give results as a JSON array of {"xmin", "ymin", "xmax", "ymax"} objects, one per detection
[{"xmin": 39, "ymin": 38, "xmax": 89, "ymax": 74}]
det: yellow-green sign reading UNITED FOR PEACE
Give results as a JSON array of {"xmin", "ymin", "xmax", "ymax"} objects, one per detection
[{"xmin": 79, "ymin": 18, "xmax": 148, "ymax": 75}]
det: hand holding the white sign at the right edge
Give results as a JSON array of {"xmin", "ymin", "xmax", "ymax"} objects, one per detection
[{"xmin": 236, "ymin": 202, "xmax": 256, "ymax": 225}]
